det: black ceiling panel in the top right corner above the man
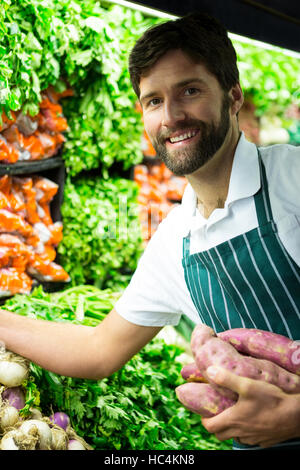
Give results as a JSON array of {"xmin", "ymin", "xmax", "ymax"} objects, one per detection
[{"xmin": 133, "ymin": 0, "xmax": 300, "ymax": 52}]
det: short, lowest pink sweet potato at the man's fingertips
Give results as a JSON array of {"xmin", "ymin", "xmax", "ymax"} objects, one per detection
[{"xmin": 175, "ymin": 382, "xmax": 236, "ymax": 418}]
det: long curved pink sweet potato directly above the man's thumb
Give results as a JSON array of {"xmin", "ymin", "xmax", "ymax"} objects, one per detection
[{"xmin": 191, "ymin": 325, "xmax": 300, "ymax": 393}]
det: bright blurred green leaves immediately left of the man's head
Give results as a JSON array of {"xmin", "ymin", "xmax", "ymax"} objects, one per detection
[{"xmin": 59, "ymin": 6, "xmax": 162, "ymax": 175}]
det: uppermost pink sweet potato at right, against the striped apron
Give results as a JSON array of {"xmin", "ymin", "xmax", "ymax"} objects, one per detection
[{"xmin": 218, "ymin": 328, "xmax": 300, "ymax": 375}]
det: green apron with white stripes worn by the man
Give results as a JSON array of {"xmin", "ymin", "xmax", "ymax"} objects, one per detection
[{"xmin": 182, "ymin": 151, "xmax": 300, "ymax": 450}]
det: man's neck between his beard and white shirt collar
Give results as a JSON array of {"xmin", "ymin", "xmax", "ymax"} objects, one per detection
[{"xmin": 186, "ymin": 129, "xmax": 240, "ymax": 219}]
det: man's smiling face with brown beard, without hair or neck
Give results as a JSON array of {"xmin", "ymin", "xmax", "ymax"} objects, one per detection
[{"xmin": 140, "ymin": 50, "xmax": 230, "ymax": 176}]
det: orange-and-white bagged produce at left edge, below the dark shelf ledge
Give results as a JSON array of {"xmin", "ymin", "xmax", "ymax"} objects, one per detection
[{"xmin": 0, "ymin": 175, "xmax": 70, "ymax": 298}]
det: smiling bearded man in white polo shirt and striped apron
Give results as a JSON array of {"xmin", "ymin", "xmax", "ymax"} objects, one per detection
[{"xmin": 0, "ymin": 14, "xmax": 300, "ymax": 449}]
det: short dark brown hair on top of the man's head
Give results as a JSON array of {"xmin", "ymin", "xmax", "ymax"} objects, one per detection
[{"xmin": 129, "ymin": 13, "xmax": 239, "ymax": 97}]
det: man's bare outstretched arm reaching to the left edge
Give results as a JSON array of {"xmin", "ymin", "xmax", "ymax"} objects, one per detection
[{"xmin": 0, "ymin": 309, "xmax": 161, "ymax": 379}]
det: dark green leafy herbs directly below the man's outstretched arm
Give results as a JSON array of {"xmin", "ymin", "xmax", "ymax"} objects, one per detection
[{"xmin": 29, "ymin": 339, "xmax": 230, "ymax": 450}]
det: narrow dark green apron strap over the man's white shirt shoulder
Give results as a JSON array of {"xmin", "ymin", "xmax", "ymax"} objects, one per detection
[{"xmin": 254, "ymin": 148, "xmax": 273, "ymax": 226}]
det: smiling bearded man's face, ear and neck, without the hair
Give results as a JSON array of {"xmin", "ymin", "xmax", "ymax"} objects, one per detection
[{"xmin": 139, "ymin": 49, "xmax": 243, "ymax": 216}]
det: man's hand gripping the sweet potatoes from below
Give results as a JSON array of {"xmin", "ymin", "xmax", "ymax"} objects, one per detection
[{"xmin": 202, "ymin": 367, "xmax": 300, "ymax": 447}]
